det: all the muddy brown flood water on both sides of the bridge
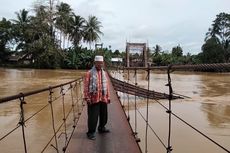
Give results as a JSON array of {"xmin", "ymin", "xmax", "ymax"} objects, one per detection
[{"xmin": 0, "ymin": 68, "xmax": 230, "ymax": 153}]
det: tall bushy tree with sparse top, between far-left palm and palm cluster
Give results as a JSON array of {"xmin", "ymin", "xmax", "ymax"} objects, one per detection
[{"xmin": 29, "ymin": 5, "xmax": 64, "ymax": 68}]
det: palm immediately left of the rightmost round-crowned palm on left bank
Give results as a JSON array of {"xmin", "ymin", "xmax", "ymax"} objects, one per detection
[{"xmin": 70, "ymin": 15, "xmax": 86, "ymax": 47}]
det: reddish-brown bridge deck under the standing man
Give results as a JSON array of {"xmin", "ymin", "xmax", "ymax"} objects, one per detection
[{"xmin": 66, "ymin": 79, "xmax": 141, "ymax": 153}]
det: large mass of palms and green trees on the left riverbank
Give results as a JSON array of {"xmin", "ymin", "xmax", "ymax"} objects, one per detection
[{"xmin": 0, "ymin": 2, "xmax": 103, "ymax": 69}]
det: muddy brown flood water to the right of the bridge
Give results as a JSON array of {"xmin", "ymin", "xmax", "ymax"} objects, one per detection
[{"xmin": 114, "ymin": 71, "xmax": 230, "ymax": 153}]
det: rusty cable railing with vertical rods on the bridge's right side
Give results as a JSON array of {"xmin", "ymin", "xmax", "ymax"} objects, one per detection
[{"xmin": 115, "ymin": 63, "xmax": 230, "ymax": 153}]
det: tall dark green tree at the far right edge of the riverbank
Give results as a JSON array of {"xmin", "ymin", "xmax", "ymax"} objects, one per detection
[{"xmin": 205, "ymin": 13, "xmax": 230, "ymax": 63}]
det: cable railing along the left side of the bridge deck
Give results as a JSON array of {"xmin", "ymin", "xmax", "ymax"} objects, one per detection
[{"xmin": 0, "ymin": 78, "xmax": 84, "ymax": 153}]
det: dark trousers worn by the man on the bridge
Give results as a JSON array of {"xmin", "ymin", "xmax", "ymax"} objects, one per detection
[{"xmin": 88, "ymin": 102, "xmax": 108, "ymax": 133}]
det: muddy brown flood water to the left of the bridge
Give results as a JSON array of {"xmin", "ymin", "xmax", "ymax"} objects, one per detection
[{"xmin": 0, "ymin": 68, "xmax": 84, "ymax": 153}]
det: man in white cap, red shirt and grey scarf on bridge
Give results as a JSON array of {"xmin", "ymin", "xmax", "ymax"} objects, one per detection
[{"xmin": 84, "ymin": 56, "xmax": 110, "ymax": 140}]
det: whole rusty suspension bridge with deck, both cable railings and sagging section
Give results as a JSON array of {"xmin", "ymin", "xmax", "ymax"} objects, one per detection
[{"xmin": 0, "ymin": 63, "xmax": 230, "ymax": 153}]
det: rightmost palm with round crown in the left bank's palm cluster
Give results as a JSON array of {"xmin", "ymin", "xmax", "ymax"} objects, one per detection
[{"xmin": 84, "ymin": 16, "xmax": 103, "ymax": 48}]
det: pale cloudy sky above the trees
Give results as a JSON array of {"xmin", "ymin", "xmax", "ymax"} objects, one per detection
[{"xmin": 0, "ymin": 0, "xmax": 230, "ymax": 54}]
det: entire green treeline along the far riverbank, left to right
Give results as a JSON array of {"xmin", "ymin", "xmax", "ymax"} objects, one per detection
[{"xmin": 0, "ymin": 1, "xmax": 230, "ymax": 69}]
